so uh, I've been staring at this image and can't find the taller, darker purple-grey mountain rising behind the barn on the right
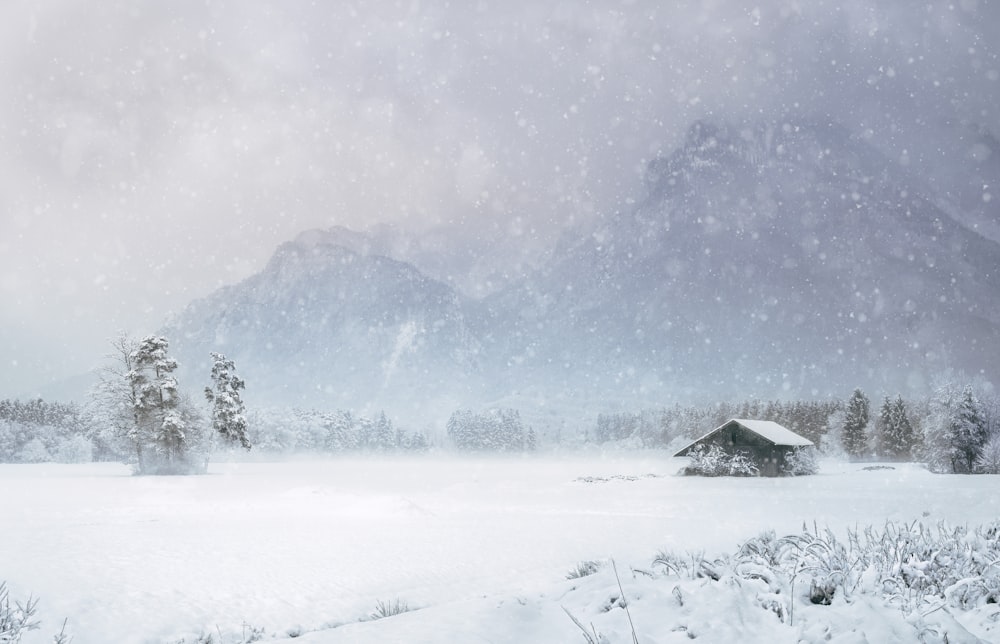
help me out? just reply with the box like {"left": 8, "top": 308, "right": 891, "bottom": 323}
{"left": 480, "top": 122, "right": 1000, "bottom": 398}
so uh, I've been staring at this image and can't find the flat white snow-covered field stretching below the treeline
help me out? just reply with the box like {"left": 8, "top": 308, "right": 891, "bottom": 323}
{"left": 0, "top": 452, "right": 1000, "bottom": 644}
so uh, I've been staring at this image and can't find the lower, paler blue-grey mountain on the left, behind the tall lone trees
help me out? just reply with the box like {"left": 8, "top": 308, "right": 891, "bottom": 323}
{"left": 164, "top": 230, "right": 479, "bottom": 422}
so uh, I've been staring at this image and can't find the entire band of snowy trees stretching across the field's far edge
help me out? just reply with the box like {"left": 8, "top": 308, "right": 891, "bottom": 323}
{"left": 0, "top": 372, "right": 1000, "bottom": 474}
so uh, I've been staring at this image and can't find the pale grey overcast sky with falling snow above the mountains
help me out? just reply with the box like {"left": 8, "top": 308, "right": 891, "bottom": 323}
{"left": 0, "top": 0, "right": 1000, "bottom": 398}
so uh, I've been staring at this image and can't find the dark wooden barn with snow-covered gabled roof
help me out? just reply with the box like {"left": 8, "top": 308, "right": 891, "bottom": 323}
{"left": 674, "top": 418, "right": 813, "bottom": 476}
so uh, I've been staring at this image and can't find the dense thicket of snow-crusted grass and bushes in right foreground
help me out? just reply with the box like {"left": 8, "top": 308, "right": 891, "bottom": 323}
{"left": 653, "top": 522, "right": 1000, "bottom": 621}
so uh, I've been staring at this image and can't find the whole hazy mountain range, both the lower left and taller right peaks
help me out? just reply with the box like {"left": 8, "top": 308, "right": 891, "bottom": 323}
{"left": 168, "top": 119, "right": 1000, "bottom": 426}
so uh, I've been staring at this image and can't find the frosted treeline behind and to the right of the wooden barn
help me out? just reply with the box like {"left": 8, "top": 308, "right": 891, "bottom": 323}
{"left": 587, "top": 382, "right": 1000, "bottom": 474}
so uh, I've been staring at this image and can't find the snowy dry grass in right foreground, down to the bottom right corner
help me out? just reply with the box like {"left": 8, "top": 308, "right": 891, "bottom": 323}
{"left": 640, "top": 522, "right": 1000, "bottom": 643}
